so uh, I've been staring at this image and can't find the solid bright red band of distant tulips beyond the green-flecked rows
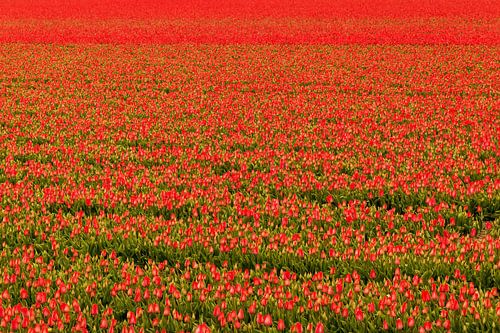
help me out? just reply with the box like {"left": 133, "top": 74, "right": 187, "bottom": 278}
{"left": 0, "top": 0, "right": 500, "bottom": 46}
